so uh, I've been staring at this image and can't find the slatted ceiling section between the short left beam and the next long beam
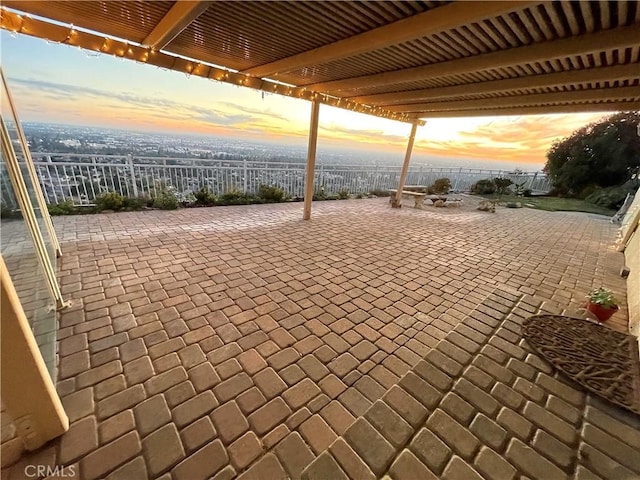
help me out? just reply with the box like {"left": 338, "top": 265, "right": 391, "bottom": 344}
{"left": 170, "top": 1, "right": 444, "bottom": 73}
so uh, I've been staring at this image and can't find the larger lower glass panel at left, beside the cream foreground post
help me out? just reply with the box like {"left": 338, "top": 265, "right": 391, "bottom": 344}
{"left": 0, "top": 155, "right": 56, "bottom": 382}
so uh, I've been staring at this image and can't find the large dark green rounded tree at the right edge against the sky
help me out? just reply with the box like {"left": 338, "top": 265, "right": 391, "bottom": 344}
{"left": 544, "top": 112, "right": 640, "bottom": 195}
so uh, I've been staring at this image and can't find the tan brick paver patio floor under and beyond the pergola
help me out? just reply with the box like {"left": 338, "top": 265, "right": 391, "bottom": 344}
{"left": 3, "top": 199, "right": 640, "bottom": 480}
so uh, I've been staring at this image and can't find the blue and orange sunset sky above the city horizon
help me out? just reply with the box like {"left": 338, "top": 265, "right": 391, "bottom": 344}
{"left": 0, "top": 30, "right": 607, "bottom": 170}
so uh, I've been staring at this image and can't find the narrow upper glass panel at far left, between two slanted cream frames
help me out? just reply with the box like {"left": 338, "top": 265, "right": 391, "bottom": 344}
{"left": 1, "top": 89, "right": 56, "bottom": 265}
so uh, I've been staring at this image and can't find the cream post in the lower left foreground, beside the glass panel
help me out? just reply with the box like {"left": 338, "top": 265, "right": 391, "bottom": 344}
{"left": 0, "top": 257, "right": 69, "bottom": 450}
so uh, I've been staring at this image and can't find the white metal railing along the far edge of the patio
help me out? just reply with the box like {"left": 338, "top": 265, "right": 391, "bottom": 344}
{"left": 0, "top": 153, "right": 551, "bottom": 205}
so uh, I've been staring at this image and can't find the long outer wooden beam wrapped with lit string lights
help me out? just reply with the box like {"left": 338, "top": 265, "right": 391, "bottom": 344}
{"left": 0, "top": 10, "right": 415, "bottom": 123}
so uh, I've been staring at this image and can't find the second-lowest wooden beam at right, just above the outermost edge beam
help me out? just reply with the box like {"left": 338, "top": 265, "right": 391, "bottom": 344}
{"left": 388, "top": 87, "right": 640, "bottom": 113}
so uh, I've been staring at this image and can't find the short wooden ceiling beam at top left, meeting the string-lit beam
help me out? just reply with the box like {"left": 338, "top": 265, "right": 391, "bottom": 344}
{"left": 142, "top": 0, "right": 213, "bottom": 50}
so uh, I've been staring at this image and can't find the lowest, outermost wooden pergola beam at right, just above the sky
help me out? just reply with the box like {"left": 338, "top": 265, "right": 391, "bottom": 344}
{"left": 408, "top": 101, "right": 640, "bottom": 119}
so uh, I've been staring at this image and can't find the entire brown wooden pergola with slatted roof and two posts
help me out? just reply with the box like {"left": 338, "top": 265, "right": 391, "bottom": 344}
{"left": 2, "top": 0, "right": 640, "bottom": 219}
